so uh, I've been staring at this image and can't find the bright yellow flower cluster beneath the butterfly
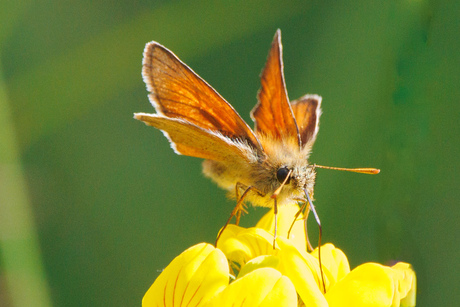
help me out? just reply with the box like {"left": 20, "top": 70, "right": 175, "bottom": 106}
{"left": 142, "top": 205, "right": 416, "bottom": 307}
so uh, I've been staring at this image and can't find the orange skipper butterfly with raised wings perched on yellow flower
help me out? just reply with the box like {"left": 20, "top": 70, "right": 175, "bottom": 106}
{"left": 134, "top": 30, "right": 379, "bottom": 254}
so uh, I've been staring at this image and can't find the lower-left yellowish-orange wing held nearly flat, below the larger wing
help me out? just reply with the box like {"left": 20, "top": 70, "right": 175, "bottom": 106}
{"left": 134, "top": 113, "right": 254, "bottom": 165}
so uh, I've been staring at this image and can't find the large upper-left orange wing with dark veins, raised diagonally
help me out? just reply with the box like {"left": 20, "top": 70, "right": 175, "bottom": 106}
{"left": 142, "top": 42, "right": 262, "bottom": 155}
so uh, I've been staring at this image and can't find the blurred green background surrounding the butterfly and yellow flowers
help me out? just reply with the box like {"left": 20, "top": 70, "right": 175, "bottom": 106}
{"left": 0, "top": 0, "right": 460, "bottom": 306}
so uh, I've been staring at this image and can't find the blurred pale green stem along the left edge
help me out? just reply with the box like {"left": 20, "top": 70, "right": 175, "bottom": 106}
{"left": 0, "top": 63, "right": 52, "bottom": 307}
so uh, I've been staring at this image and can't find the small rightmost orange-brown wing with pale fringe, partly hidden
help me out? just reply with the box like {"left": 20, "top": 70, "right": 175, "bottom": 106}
{"left": 291, "top": 95, "right": 321, "bottom": 147}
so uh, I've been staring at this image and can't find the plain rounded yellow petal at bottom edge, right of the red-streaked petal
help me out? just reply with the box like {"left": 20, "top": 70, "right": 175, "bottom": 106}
{"left": 205, "top": 268, "right": 297, "bottom": 307}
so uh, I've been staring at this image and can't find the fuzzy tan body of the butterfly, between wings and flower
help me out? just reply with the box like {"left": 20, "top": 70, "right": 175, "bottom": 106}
{"left": 203, "top": 135, "right": 316, "bottom": 207}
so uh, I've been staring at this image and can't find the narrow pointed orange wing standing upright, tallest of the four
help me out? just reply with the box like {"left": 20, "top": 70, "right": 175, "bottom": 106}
{"left": 251, "top": 30, "right": 300, "bottom": 146}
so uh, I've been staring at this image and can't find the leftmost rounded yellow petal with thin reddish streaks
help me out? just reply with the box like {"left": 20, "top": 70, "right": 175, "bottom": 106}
{"left": 142, "top": 243, "right": 229, "bottom": 307}
